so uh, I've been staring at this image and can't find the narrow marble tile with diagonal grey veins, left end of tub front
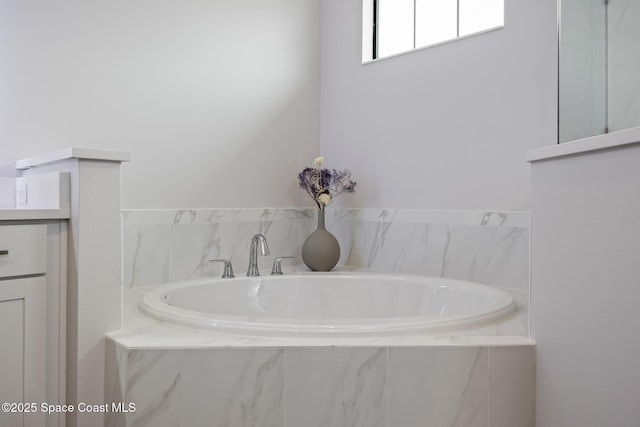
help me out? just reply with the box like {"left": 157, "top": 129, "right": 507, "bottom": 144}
{"left": 125, "top": 349, "right": 180, "bottom": 427}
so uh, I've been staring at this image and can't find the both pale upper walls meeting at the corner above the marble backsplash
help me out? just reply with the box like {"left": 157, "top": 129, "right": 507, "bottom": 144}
{"left": 0, "top": 0, "right": 556, "bottom": 210}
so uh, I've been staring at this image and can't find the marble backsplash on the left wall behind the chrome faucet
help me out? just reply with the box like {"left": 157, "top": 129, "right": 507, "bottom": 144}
{"left": 122, "top": 209, "right": 313, "bottom": 288}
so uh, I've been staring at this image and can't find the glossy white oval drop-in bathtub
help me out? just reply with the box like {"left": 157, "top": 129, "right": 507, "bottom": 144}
{"left": 140, "top": 273, "right": 515, "bottom": 338}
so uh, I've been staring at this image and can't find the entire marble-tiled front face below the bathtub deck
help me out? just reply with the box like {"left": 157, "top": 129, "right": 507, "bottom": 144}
{"left": 106, "top": 339, "right": 535, "bottom": 427}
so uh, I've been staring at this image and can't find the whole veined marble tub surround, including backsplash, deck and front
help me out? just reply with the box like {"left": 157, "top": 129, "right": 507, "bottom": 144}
{"left": 116, "top": 209, "right": 535, "bottom": 427}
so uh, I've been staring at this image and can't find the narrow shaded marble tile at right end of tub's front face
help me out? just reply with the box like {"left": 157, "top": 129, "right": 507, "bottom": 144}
{"left": 489, "top": 345, "right": 536, "bottom": 427}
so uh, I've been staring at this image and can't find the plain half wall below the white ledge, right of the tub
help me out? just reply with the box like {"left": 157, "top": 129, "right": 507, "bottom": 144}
{"left": 531, "top": 144, "right": 640, "bottom": 427}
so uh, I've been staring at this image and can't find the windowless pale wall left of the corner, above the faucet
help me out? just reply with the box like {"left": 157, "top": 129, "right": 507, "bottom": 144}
{"left": 0, "top": 0, "right": 320, "bottom": 208}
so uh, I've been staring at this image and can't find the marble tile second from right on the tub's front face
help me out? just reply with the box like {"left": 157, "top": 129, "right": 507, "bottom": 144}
{"left": 389, "top": 347, "right": 489, "bottom": 427}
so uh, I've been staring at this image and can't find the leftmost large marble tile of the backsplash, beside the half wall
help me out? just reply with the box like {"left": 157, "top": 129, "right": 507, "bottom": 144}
{"left": 122, "top": 224, "right": 171, "bottom": 288}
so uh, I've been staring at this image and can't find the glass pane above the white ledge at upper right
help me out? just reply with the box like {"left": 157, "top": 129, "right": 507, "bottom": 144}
{"left": 558, "top": 0, "right": 640, "bottom": 143}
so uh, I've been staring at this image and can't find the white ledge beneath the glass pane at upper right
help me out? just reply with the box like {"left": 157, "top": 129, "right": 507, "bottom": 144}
{"left": 526, "top": 127, "right": 640, "bottom": 162}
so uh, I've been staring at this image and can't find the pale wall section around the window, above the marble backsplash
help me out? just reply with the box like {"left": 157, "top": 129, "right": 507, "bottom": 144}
{"left": 321, "top": 0, "right": 557, "bottom": 210}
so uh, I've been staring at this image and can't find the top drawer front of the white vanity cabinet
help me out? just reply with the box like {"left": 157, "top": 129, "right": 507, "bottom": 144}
{"left": 0, "top": 224, "right": 47, "bottom": 278}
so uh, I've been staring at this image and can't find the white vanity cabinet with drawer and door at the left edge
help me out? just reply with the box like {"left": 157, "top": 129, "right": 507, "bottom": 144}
{"left": 0, "top": 221, "right": 66, "bottom": 427}
